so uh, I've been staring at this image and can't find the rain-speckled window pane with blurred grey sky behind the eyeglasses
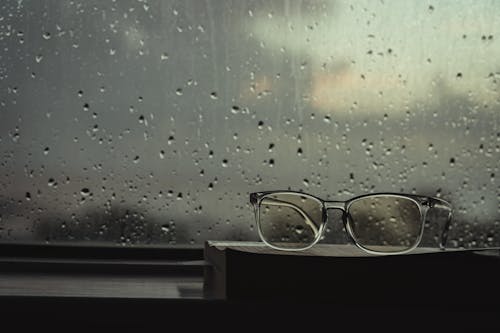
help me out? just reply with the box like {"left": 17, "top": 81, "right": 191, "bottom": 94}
{"left": 0, "top": 0, "right": 500, "bottom": 246}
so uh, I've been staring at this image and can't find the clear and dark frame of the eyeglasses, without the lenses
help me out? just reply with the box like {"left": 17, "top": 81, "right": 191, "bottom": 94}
{"left": 250, "top": 190, "right": 452, "bottom": 255}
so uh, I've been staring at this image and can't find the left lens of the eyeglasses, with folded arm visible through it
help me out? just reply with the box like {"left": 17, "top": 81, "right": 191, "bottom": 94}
{"left": 259, "top": 193, "right": 323, "bottom": 249}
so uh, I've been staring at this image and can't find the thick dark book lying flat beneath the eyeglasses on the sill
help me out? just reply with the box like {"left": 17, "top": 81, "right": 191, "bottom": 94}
{"left": 204, "top": 241, "right": 500, "bottom": 306}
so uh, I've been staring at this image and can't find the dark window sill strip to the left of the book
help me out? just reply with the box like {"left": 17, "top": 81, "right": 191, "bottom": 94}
{"left": 0, "top": 244, "right": 206, "bottom": 300}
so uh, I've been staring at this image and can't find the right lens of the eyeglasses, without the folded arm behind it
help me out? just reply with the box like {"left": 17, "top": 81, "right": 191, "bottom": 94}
{"left": 348, "top": 195, "right": 423, "bottom": 253}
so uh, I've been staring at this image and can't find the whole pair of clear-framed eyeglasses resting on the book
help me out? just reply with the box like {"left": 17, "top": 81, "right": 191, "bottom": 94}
{"left": 250, "top": 191, "right": 452, "bottom": 254}
